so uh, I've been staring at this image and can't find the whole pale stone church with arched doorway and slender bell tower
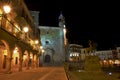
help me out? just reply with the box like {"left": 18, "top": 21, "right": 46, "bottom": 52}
{"left": 32, "top": 11, "right": 66, "bottom": 66}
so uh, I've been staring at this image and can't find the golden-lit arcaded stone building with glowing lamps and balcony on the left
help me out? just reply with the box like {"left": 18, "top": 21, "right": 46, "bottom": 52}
{"left": 0, "top": 0, "right": 40, "bottom": 73}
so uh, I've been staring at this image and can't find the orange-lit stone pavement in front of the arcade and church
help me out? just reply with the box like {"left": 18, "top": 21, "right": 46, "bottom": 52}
{"left": 0, "top": 67, "right": 68, "bottom": 80}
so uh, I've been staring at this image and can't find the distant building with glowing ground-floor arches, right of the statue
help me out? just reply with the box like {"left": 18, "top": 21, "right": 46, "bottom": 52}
{"left": 95, "top": 47, "right": 120, "bottom": 67}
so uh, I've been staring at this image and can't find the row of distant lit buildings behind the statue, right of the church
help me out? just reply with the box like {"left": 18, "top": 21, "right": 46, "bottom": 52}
{"left": 68, "top": 44, "right": 120, "bottom": 68}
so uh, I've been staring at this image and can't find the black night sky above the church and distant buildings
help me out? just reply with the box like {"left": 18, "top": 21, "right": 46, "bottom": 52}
{"left": 24, "top": 0, "right": 120, "bottom": 50}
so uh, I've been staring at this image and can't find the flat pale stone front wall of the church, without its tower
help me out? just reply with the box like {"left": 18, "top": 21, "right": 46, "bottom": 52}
{"left": 39, "top": 26, "right": 65, "bottom": 65}
